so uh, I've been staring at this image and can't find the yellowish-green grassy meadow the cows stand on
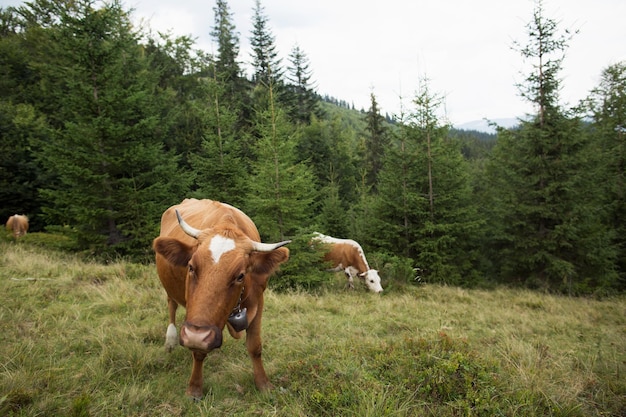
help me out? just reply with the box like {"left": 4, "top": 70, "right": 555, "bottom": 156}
{"left": 0, "top": 241, "right": 626, "bottom": 417}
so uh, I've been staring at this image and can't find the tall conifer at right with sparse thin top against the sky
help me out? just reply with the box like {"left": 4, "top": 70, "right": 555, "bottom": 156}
{"left": 490, "top": 2, "right": 612, "bottom": 292}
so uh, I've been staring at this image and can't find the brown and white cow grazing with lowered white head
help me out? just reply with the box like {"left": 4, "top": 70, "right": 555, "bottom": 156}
{"left": 313, "top": 232, "right": 383, "bottom": 293}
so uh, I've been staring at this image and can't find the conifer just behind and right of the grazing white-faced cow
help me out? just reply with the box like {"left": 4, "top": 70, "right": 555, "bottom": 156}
{"left": 375, "top": 80, "right": 481, "bottom": 285}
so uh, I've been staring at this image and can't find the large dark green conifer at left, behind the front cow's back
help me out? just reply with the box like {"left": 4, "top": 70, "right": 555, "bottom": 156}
{"left": 26, "top": 0, "right": 189, "bottom": 255}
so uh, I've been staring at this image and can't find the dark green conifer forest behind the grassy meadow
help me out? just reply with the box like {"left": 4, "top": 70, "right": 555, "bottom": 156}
{"left": 0, "top": 0, "right": 626, "bottom": 296}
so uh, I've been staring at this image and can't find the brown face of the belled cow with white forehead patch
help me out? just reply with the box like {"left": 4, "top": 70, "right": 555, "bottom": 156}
{"left": 154, "top": 213, "right": 289, "bottom": 352}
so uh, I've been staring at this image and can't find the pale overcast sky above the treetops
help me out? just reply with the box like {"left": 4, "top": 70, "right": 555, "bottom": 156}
{"left": 0, "top": 0, "right": 626, "bottom": 125}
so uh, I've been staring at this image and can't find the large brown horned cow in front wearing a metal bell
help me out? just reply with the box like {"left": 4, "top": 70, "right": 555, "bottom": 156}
{"left": 153, "top": 199, "right": 289, "bottom": 398}
